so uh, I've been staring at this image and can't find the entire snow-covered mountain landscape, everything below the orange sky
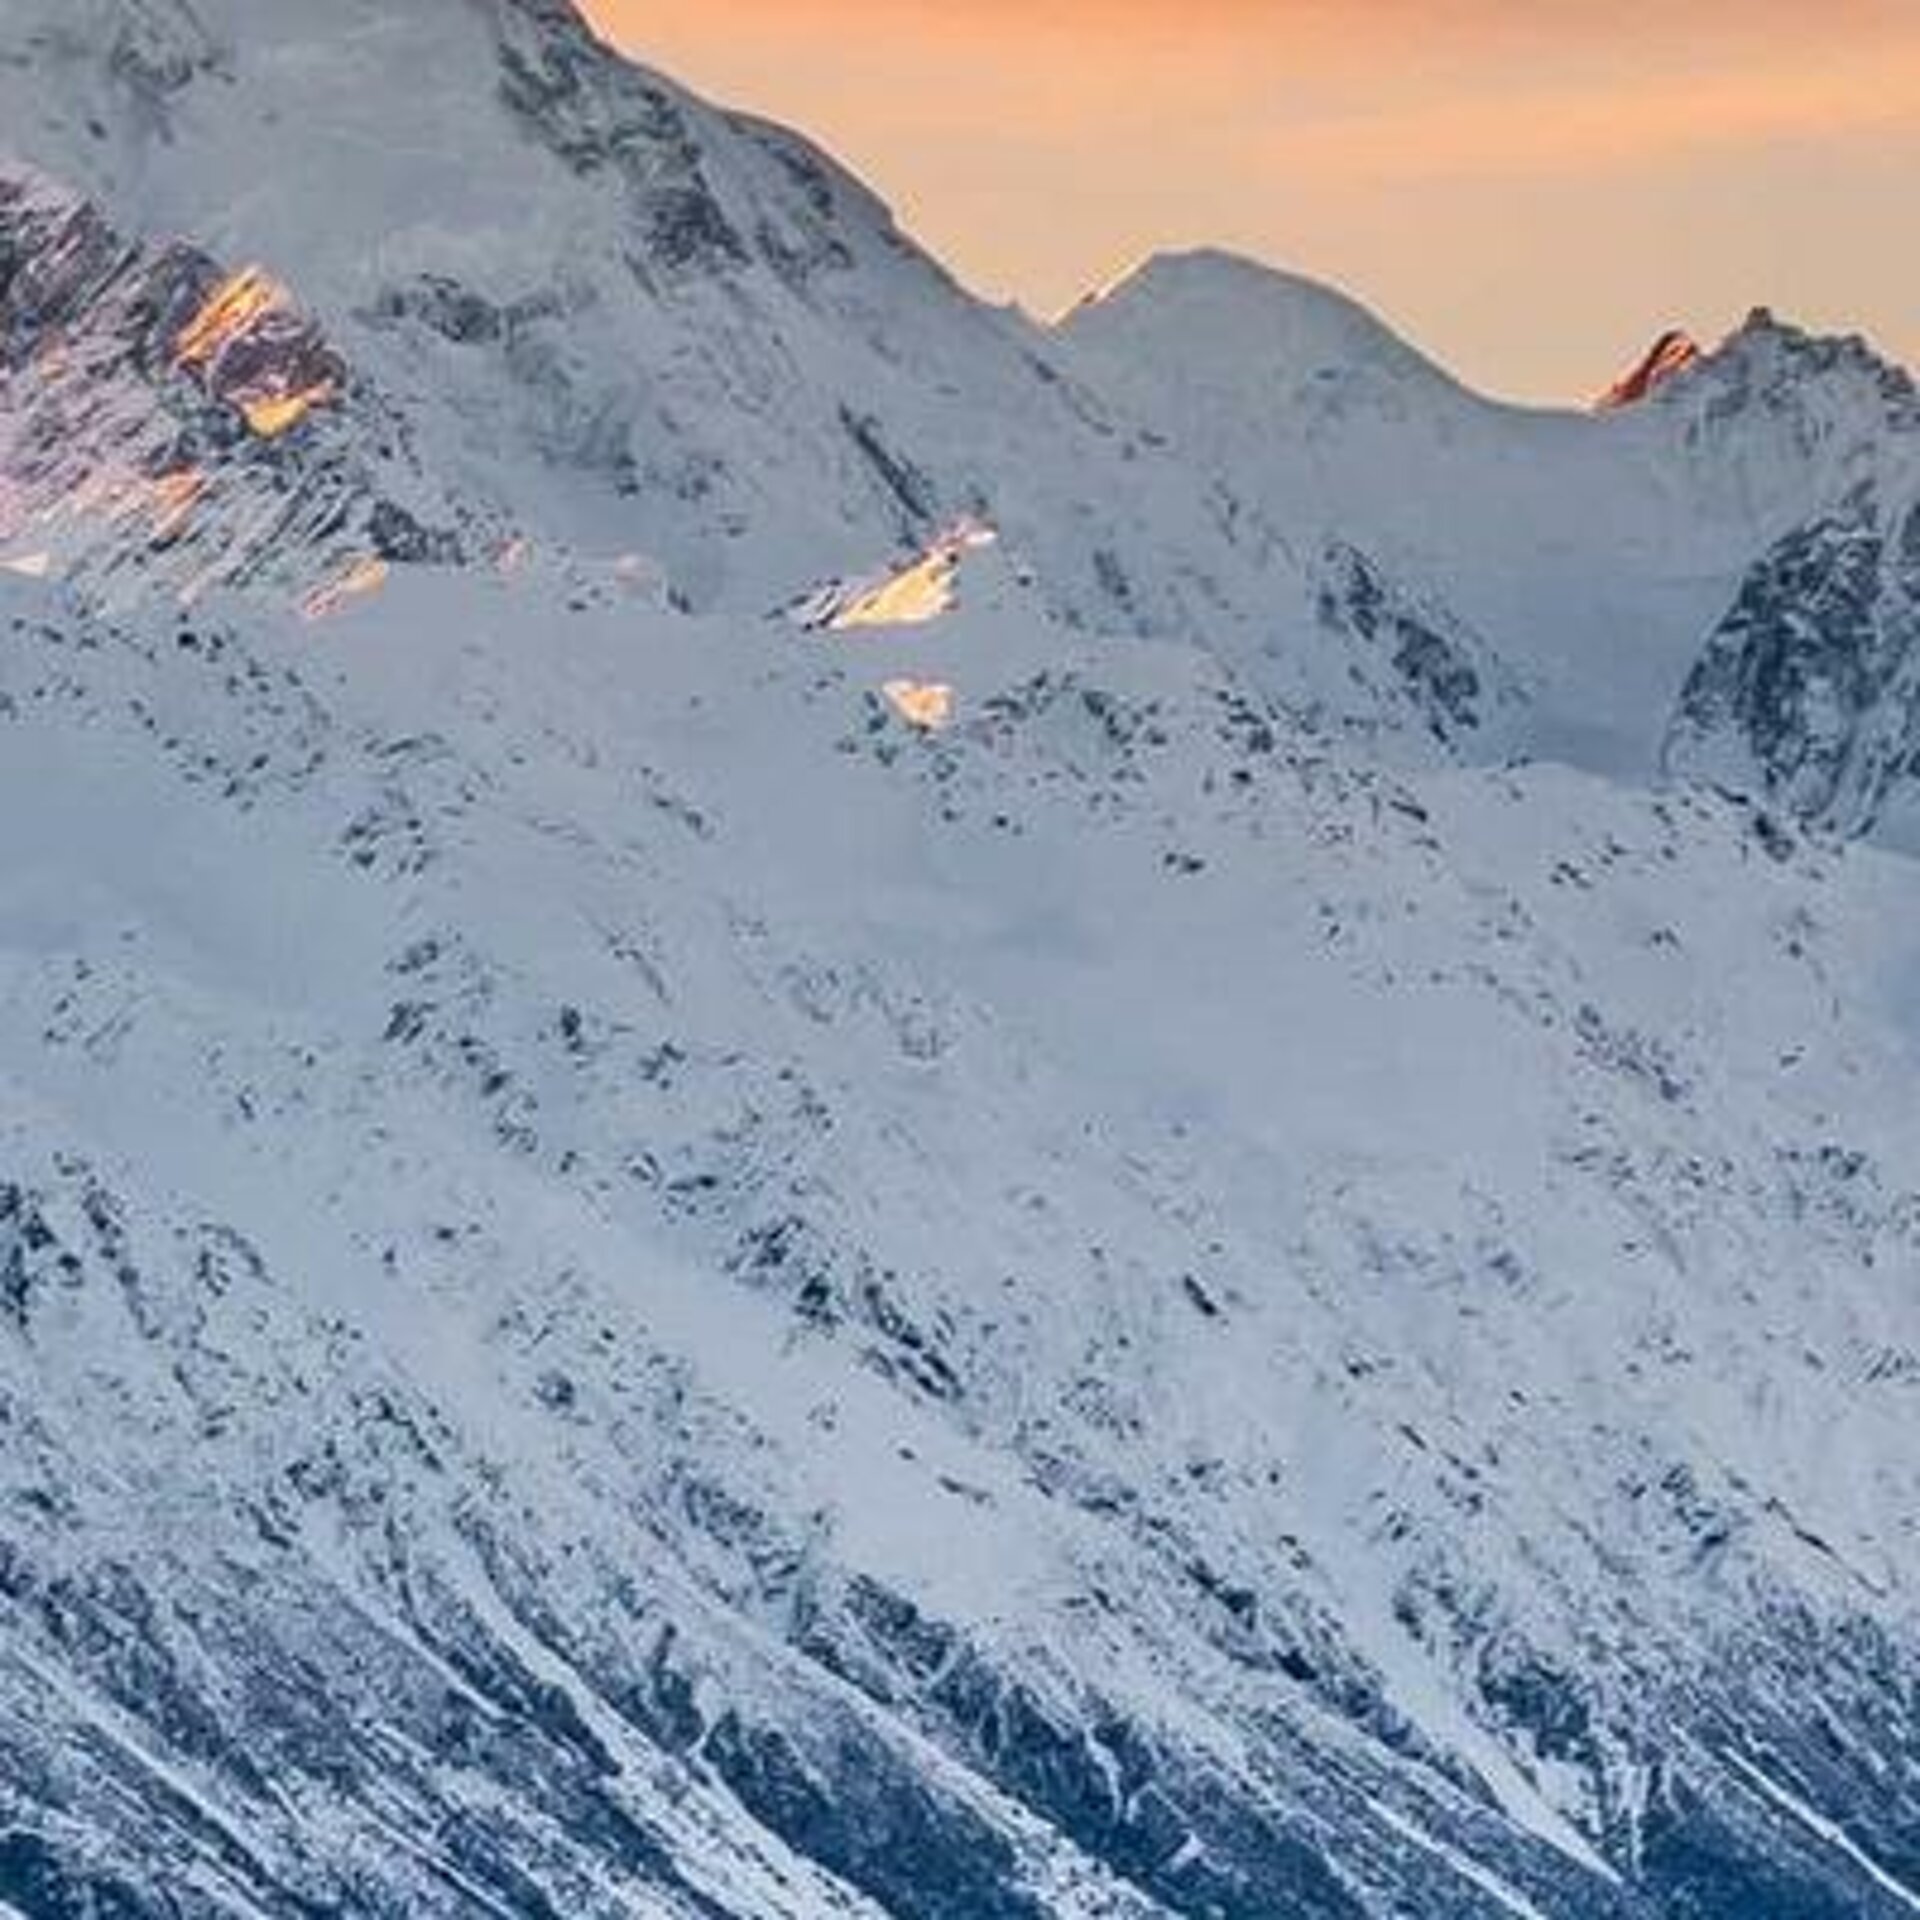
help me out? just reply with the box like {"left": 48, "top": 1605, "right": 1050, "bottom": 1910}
{"left": 0, "top": 0, "right": 1920, "bottom": 1920}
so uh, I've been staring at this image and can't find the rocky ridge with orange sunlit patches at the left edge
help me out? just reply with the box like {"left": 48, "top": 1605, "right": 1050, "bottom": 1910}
{"left": 0, "top": 169, "right": 465, "bottom": 599}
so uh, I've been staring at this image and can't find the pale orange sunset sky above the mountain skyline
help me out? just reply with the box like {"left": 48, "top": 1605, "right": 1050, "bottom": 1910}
{"left": 589, "top": 0, "right": 1920, "bottom": 399}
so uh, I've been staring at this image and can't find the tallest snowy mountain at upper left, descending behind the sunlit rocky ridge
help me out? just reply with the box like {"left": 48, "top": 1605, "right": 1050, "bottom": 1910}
{"left": 0, "top": 0, "right": 1304, "bottom": 652}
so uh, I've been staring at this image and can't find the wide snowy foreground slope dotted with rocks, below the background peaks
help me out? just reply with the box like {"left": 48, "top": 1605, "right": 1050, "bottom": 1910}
{"left": 0, "top": 549, "right": 1920, "bottom": 1914}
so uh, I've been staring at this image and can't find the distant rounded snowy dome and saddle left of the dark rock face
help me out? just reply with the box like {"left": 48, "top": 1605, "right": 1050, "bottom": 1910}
{"left": 1064, "top": 253, "right": 1920, "bottom": 806}
